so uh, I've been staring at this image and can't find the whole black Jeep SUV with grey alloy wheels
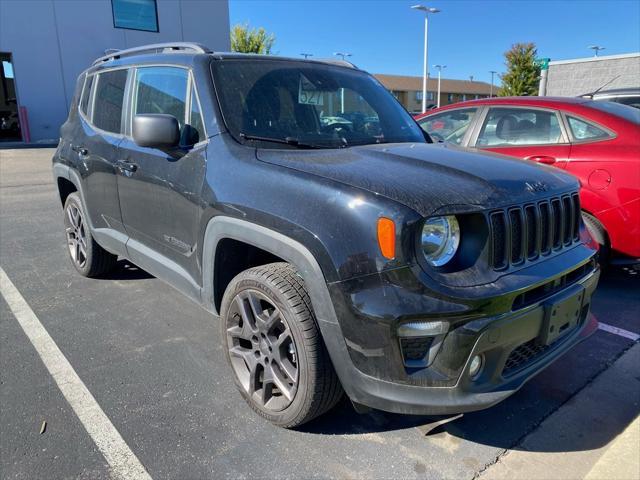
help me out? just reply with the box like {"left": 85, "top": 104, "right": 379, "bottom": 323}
{"left": 53, "top": 44, "right": 599, "bottom": 427}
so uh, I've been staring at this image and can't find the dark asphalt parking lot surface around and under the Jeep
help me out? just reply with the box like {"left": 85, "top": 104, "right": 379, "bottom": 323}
{"left": 0, "top": 149, "right": 640, "bottom": 479}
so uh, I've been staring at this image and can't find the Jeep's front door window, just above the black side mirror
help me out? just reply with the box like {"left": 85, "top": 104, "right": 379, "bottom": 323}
{"left": 133, "top": 67, "right": 189, "bottom": 128}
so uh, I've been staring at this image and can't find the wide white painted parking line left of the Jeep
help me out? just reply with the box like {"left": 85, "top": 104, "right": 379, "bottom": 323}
{"left": 0, "top": 267, "right": 151, "bottom": 479}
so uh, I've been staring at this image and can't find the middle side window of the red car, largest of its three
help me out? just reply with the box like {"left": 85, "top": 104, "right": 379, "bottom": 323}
{"left": 476, "top": 108, "right": 562, "bottom": 147}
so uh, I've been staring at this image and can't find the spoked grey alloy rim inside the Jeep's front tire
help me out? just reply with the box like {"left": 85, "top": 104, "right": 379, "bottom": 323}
{"left": 226, "top": 290, "right": 299, "bottom": 411}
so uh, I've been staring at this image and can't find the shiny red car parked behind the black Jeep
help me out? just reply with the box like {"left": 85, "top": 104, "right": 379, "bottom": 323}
{"left": 416, "top": 97, "right": 640, "bottom": 264}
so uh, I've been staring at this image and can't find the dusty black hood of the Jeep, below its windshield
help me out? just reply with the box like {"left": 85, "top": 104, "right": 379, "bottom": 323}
{"left": 257, "top": 143, "right": 579, "bottom": 216}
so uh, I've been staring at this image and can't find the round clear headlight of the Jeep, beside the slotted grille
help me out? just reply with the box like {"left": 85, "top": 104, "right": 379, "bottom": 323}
{"left": 421, "top": 215, "right": 460, "bottom": 267}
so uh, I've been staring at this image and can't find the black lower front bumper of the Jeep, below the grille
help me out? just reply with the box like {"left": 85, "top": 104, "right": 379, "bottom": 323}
{"left": 322, "top": 253, "right": 600, "bottom": 415}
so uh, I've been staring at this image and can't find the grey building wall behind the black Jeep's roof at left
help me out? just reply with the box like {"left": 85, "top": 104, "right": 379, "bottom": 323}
{"left": 0, "top": 0, "right": 230, "bottom": 141}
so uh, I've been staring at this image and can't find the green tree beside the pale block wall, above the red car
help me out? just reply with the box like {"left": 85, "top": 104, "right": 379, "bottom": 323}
{"left": 498, "top": 43, "right": 540, "bottom": 97}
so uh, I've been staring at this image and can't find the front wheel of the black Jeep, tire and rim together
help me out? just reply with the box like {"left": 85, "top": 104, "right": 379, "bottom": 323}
{"left": 220, "top": 263, "right": 343, "bottom": 428}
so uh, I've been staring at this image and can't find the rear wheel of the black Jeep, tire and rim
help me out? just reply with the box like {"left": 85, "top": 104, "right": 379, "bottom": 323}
{"left": 64, "top": 192, "right": 118, "bottom": 277}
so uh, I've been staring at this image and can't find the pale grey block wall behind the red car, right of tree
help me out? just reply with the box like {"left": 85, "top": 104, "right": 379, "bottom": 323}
{"left": 547, "top": 53, "right": 640, "bottom": 97}
